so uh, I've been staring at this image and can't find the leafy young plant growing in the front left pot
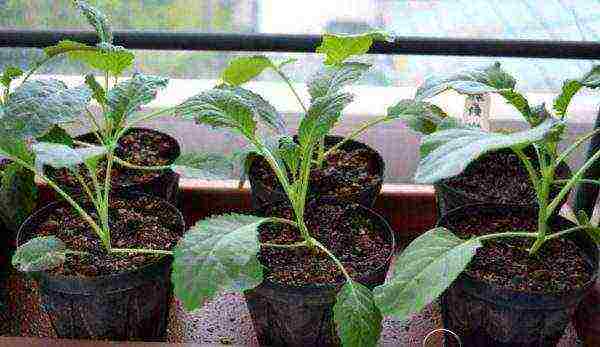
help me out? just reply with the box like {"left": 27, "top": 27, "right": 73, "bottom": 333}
{"left": 11, "top": 1, "right": 232, "bottom": 271}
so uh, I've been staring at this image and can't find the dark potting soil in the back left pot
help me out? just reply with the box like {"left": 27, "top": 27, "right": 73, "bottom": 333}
{"left": 45, "top": 129, "right": 178, "bottom": 189}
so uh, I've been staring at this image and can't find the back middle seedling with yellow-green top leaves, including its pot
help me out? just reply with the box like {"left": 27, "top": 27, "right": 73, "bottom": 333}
{"left": 221, "top": 33, "right": 404, "bottom": 210}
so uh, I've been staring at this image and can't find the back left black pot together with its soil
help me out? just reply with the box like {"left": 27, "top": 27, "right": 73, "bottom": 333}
{"left": 45, "top": 128, "right": 180, "bottom": 203}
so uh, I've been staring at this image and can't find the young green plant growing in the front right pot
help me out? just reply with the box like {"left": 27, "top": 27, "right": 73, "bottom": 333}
{"left": 375, "top": 66, "right": 600, "bottom": 319}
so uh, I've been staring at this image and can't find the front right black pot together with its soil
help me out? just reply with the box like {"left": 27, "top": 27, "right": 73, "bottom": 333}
{"left": 440, "top": 204, "right": 598, "bottom": 347}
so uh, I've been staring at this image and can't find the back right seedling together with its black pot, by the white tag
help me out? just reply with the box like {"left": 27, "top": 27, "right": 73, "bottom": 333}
{"left": 399, "top": 62, "right": 570, "bottom": 216}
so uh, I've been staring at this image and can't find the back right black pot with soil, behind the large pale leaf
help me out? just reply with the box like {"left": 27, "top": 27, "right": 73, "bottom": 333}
{"left": 435, "top": 149, "right": 570, "bottom": 216}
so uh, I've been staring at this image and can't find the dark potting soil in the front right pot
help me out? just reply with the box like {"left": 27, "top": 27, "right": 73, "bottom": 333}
{"left": 444, "top": 208, "right": 593, "bottom": 294}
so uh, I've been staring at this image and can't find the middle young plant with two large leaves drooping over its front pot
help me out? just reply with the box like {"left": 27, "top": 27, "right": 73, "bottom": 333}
{"left": 164, "top": 34, "right": 440, "bottom": 346}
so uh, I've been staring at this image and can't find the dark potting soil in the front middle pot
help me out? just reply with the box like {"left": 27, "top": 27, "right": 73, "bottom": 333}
{"left": 259, "top": 204, "right": 392, "bottom": 286}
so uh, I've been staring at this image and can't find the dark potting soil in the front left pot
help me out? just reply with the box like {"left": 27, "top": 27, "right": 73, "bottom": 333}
{"left": 30, "top": 196, "right": 182, "bottom": 277}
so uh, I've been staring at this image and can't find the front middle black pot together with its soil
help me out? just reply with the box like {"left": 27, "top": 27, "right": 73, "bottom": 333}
{"left": 245, "top": 203, "right": 394, "bottom": 346}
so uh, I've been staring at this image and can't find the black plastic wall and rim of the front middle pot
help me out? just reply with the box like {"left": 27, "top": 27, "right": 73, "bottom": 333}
{"left": 244, "top": 199, "right": 395, "bottom": 346}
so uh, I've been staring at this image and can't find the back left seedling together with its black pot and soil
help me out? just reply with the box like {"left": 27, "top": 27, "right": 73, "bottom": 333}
{"left": 31, "top": 1, "right": 180, "bottom": 202}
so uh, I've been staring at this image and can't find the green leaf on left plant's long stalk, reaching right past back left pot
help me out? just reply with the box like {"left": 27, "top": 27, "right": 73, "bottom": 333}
{"left": 171, "top": 152, "right": 234, "bottom": 180}
